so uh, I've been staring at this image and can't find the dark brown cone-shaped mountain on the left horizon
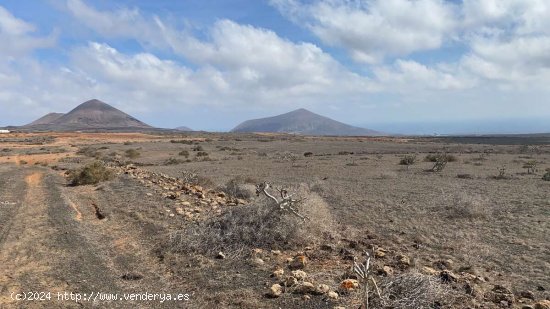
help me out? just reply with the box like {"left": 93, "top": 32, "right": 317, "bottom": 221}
{"left": 25, "top": 99, "right": 151, "bottom": 131}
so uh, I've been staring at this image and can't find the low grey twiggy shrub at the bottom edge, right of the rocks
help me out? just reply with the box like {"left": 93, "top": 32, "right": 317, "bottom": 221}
{"left": 372, "top": 272, "right": 457, "bottom": 309}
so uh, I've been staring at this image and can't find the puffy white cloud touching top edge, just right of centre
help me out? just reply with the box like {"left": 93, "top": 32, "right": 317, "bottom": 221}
{"left": 272, "top": 0, "right": 457, "bottom": 64}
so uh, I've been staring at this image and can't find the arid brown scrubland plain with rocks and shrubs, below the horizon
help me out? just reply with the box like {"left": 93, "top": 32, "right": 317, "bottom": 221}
{"left": 0, "top": 133, "right": 550, "bottom": 308}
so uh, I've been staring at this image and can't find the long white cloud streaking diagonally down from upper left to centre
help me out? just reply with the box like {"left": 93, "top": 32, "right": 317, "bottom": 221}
{"left": 68, "top": 0, "right": 369, "bottom": 94}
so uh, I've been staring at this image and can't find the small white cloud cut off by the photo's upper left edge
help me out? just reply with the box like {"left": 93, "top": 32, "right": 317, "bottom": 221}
{"left": 0, "top": 6, "right": 57, "bottom": 57}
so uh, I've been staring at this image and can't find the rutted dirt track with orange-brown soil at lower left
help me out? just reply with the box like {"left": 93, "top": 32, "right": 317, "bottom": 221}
{"left": 0, "top": 165, "right": 183, "bottom": 308}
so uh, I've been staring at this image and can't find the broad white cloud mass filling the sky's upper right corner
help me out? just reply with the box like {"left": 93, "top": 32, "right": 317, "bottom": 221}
{"left": 271, "top": 0, "right": 550, "bottom": 89}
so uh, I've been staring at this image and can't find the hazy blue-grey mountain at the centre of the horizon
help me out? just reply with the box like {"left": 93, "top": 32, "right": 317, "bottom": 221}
{"left": 231, "top": 108, "right": 380, "bottom": 136}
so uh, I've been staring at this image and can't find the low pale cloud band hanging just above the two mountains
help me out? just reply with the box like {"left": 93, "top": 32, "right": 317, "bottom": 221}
{"left": 68, "top": 37, "right": 369, "bottom": 106}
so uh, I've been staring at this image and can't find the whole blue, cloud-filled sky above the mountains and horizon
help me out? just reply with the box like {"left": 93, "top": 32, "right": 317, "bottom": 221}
{"left": 0, "top": 0, "right": 550, "bottom": 134}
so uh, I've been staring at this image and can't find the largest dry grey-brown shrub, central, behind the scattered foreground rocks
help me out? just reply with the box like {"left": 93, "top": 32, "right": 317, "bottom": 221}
{"left": 170, "top": 185, "right": 335, "bottom": 257}
